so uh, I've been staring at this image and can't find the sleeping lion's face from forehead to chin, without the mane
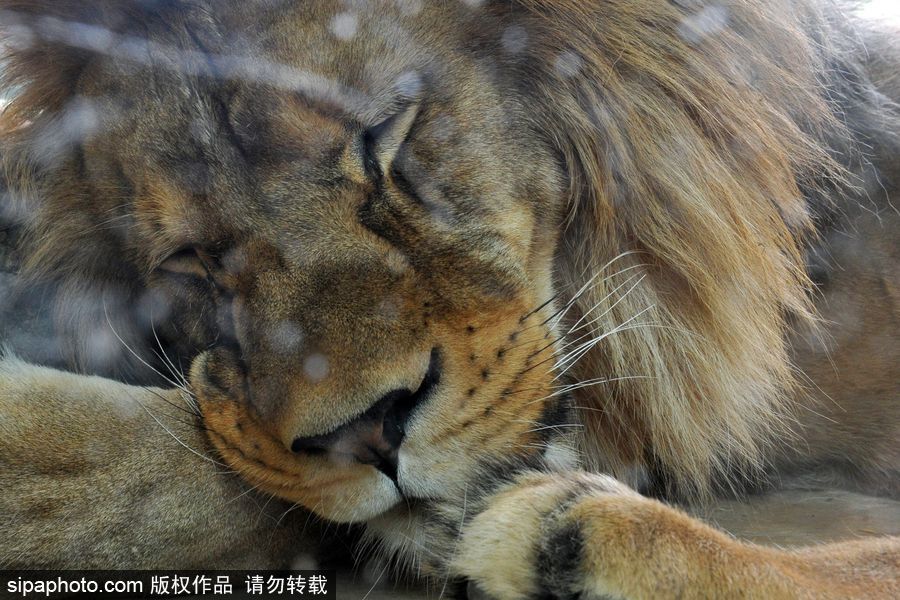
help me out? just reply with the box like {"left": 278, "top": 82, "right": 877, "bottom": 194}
{"left": 3, "top": 2, "right": 565, "bottom": 520}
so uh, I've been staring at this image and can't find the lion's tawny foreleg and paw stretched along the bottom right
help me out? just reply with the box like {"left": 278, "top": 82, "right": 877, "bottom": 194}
{"left": 452, "top": 473, "right": 900, "bottom": 600}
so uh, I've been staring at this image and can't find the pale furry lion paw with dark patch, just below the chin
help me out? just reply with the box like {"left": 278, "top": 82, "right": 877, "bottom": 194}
{"left": 452, "top": 473, "right": 650, "bottom": 600}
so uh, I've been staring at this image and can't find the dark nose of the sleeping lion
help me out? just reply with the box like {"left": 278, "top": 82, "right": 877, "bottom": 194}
{"left": 291, "top": 349, "right": 441, "bottom": 483}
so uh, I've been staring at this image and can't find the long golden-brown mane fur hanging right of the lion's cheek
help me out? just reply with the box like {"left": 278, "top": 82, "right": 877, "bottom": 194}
{"left": 520, "top": 2, "right": 839, "bottom": 486}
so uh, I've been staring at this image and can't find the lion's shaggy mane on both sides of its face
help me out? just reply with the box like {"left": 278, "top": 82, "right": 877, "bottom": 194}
{"left": 0, "top": 0, "right": 883, "bottom": 494}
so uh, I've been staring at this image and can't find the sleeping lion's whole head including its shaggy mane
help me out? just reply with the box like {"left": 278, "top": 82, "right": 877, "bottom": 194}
{"left": 0, "top": 0, "right": 856, "bottom": 520}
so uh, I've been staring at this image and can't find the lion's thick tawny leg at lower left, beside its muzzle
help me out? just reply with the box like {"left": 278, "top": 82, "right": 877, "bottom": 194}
{"left": 0, "top": 357, "right": 309, "bottom": 569}
